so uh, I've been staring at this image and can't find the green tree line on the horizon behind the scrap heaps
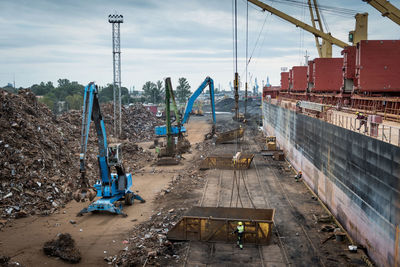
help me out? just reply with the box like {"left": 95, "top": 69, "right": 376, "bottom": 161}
{"left": 0, "top": 78, "right": 191, "bottom": 111}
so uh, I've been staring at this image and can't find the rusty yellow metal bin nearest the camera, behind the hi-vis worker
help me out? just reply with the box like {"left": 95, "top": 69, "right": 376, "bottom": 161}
{"left": 167, "top": 207, "right": 275, "bottom": 245}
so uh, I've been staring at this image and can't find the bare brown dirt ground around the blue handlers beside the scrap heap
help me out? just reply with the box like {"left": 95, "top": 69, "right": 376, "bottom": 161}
{"left": 0, "top": 119, "right": 211, "bottom": 266}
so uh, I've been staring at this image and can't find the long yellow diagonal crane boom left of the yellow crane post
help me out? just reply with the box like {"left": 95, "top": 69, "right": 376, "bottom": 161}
{"left": 247, "top": 0, "right": 349, "bottom": 48}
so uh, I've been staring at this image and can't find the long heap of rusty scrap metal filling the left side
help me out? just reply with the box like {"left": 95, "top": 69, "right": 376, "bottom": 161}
{"left": 0, "top": 90, "right": 159, "bottom": 222}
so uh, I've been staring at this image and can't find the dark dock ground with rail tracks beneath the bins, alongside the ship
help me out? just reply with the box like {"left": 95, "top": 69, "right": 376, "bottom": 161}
{"left": 184, "top": 122, "right": 350, "bottom": 266}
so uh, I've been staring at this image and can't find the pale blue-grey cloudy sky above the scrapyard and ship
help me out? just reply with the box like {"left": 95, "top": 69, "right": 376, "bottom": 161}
{"left": 0, "top": 0, "right": 400, "bottom": 90}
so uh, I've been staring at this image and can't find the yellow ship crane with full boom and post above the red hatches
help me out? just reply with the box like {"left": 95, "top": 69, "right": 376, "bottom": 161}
{"left": 247, "top": 0, "right": 368, "bottom": 57}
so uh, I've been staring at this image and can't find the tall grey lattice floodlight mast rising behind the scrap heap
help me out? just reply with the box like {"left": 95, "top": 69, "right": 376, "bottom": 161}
{"left": 108, "top": 14, "right": 124, "bottom": 138}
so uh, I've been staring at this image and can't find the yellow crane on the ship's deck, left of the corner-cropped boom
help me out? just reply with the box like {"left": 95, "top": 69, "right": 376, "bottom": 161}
{"left": 247, "top": 0, "right": 367, "bottom": 57}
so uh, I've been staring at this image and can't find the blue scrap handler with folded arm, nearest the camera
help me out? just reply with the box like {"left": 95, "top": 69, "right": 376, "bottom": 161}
{"left": 74, "top": 82, "right": 145, "bottom": 215}
